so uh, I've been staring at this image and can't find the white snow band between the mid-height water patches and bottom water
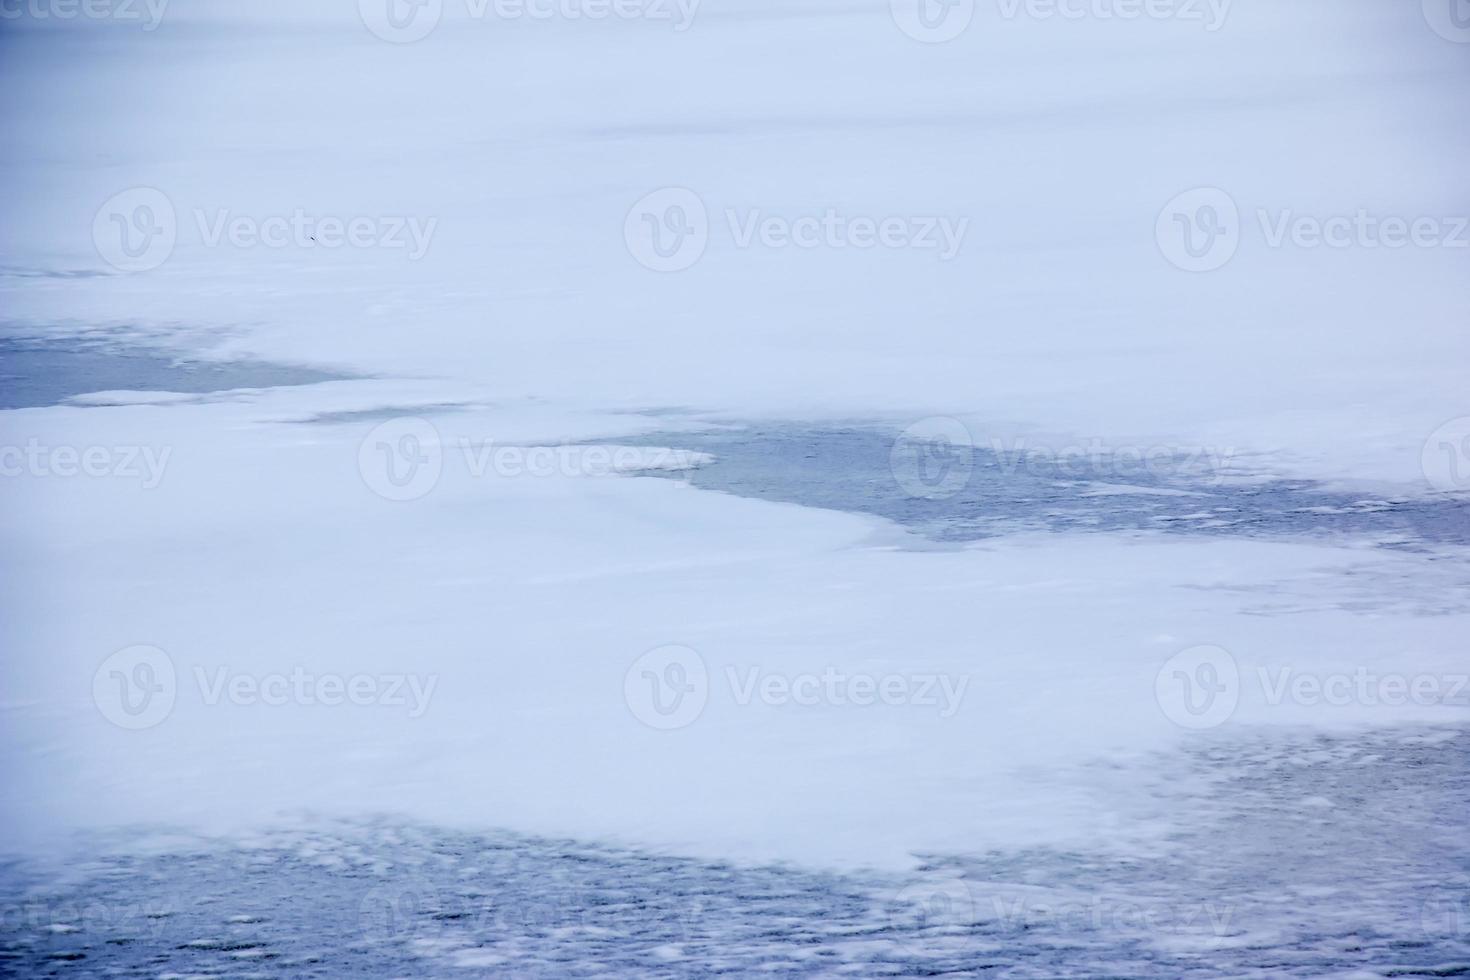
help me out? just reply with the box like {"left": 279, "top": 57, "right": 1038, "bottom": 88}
{"left": 0, "top": 382, "right": 1470, "bottom": 867}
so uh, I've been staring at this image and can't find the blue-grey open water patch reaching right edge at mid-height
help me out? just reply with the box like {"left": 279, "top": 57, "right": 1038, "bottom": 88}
{"left": 620, "top": 423, "right": 1470, "bottom": 550}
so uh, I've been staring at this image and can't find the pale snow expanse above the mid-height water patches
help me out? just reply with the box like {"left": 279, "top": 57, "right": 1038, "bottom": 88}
{"left": 0, "top": 0, "right": 1470, "bottom": 483}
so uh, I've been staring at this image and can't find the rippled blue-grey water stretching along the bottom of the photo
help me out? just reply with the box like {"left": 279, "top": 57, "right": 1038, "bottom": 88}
{"left": 0, "top": 730, "right": 1470, "bottom": 979}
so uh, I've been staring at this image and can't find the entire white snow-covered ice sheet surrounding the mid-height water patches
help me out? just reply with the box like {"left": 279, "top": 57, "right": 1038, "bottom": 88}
{"left": 0, "top": 0, "right": 1470, "bottom": 967}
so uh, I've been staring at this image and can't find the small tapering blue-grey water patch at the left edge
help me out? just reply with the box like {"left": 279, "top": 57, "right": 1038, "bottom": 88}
{"left": 0, "top": 338, "right": 341, "bottom": 410}
